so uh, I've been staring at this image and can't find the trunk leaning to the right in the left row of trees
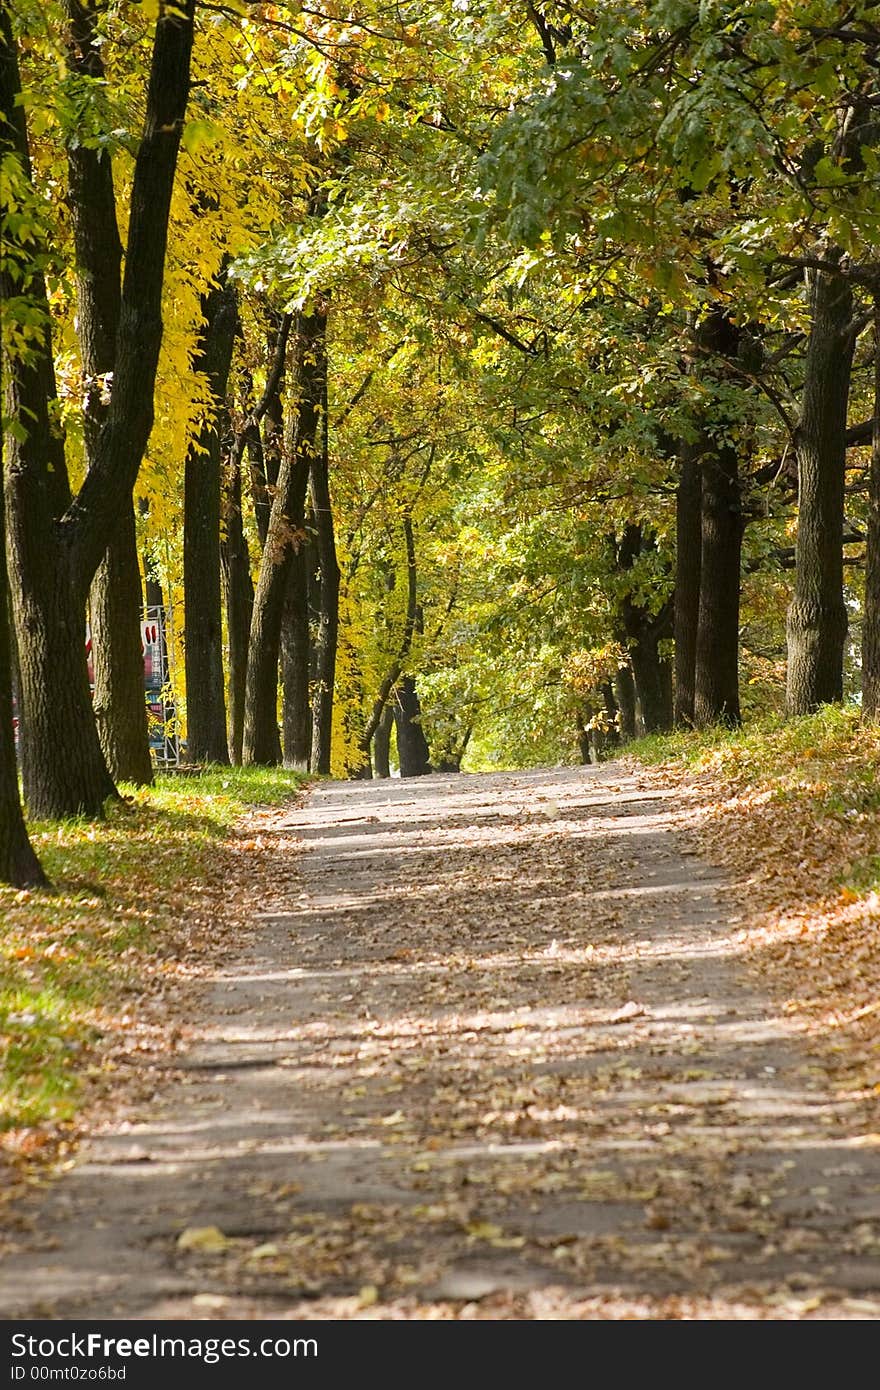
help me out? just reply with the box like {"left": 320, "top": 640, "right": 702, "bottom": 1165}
{"left": 243, "top": 310, "right": 316, "bottom": 766}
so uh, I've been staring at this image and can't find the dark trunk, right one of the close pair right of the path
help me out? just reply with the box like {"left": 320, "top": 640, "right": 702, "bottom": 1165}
{"left": 694, "top": 443, "right": 742, "bottom": 728}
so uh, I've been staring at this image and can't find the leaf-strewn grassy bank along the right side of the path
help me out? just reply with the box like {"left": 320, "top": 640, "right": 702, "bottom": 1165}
{"left": 627, "top": 706, "right": 880, "bottom": 1095}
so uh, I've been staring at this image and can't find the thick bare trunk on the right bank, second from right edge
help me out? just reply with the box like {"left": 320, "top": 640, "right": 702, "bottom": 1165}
{"left": 785, "top": 259, "right": 855, "bottom": 714}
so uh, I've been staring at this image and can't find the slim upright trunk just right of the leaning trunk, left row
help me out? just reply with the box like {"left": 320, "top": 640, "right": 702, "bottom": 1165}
{"left": 309, "top": 332, "right": 339, "bottom": 774}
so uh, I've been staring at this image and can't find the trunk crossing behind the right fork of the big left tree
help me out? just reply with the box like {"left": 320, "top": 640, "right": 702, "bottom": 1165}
{"left": 64, "top": 0, "right": 153, "bottom": 785}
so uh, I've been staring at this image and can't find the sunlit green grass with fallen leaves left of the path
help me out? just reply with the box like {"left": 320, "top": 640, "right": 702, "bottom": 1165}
{"left": 0, "top": 767, "right": 303, "bottom": 1138}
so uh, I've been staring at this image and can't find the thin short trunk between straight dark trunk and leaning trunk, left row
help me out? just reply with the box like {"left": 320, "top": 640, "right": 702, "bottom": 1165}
{"left": 221, "top": 456, "right": 253, "bottom": 767}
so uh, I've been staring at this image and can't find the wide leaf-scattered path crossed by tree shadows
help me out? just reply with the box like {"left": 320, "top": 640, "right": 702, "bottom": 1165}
{"left": 0, "top": 765, "right": 880, "bottom": 1319}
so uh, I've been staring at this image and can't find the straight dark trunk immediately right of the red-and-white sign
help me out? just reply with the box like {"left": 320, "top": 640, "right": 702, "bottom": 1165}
{"left": 184, "top": 276, "right": 238, "bottom": 763}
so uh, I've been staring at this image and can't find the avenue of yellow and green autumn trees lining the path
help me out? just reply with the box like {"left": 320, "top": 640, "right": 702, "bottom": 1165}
{"left": 0, "top": 0, "right": 880, "bottom": 884}
